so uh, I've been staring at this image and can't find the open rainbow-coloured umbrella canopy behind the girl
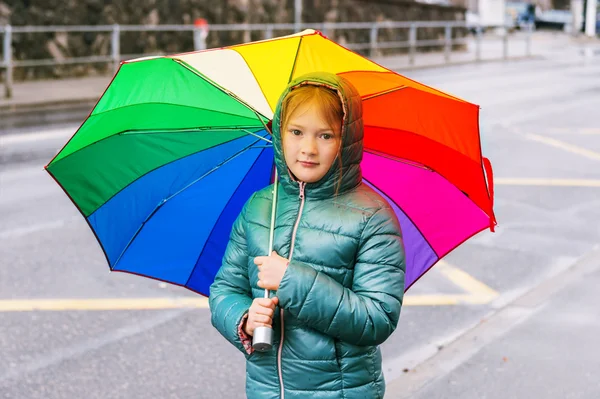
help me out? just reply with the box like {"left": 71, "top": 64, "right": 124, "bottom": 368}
{"left": 46, "top": 30, "right": 495, "bottom": 295}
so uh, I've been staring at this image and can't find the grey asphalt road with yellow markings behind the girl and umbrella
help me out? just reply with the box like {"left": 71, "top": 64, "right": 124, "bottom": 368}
{"left": 0, "top": 32, "right": 600, "bottom": 399}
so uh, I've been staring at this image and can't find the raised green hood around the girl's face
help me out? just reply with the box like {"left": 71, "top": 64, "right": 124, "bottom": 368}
{"left": 272, "top": 72, "right": 363, "bottom": 198}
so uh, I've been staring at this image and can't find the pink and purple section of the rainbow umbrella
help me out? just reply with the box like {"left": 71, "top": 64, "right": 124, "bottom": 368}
{"left": 361, "top": 152, "right": 490, "bottom": 290}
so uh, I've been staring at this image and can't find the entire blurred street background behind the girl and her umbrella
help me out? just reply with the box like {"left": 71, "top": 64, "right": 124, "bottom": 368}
{"left": 0, "top": 0, "right": 600, "bottom": 399}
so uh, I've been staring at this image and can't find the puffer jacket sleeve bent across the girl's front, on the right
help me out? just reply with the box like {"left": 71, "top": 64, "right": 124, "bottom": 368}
{"left": 277, "top": 208, "right": 405, "bottom": 345}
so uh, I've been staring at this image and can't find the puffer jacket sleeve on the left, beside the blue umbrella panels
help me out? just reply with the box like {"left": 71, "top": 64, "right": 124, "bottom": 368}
{"left": 208, "top": 197, "right": 252, "bottom": 355}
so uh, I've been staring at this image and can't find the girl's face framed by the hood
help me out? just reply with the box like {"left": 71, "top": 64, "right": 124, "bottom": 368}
{"left": 282, "top": 104, "right": 342, "bottom": 183}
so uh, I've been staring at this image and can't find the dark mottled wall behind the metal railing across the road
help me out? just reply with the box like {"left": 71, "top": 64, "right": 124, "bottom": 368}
{"left": 0, "top": 0, "right": 465, "bottom": 80}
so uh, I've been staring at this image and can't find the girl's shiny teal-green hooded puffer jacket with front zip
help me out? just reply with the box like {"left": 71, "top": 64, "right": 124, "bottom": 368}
{"left": 210, "top": 73, "right": 405, "bottom": 399}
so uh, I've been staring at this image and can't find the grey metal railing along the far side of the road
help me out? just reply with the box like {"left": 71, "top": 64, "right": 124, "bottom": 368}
{"left": 0, "top": 21, "right": 531, "bottom": 98}
